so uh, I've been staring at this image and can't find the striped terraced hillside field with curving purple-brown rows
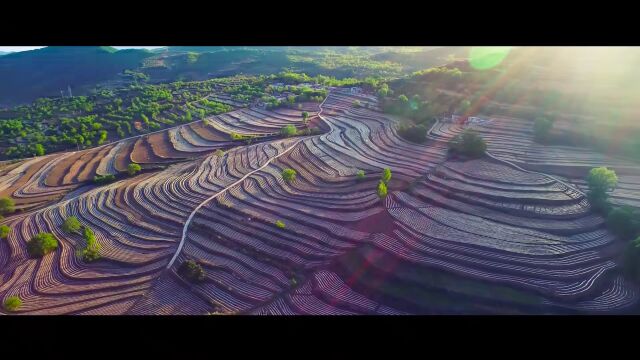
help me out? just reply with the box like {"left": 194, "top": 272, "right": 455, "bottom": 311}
{"left": 0, "top": 90, "right": 638, "bottom": 315}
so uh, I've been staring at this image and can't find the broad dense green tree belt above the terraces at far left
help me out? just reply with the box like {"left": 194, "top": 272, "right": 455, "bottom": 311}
{"left": 0, "top": 80, "right": 231, "bottom": 158}
